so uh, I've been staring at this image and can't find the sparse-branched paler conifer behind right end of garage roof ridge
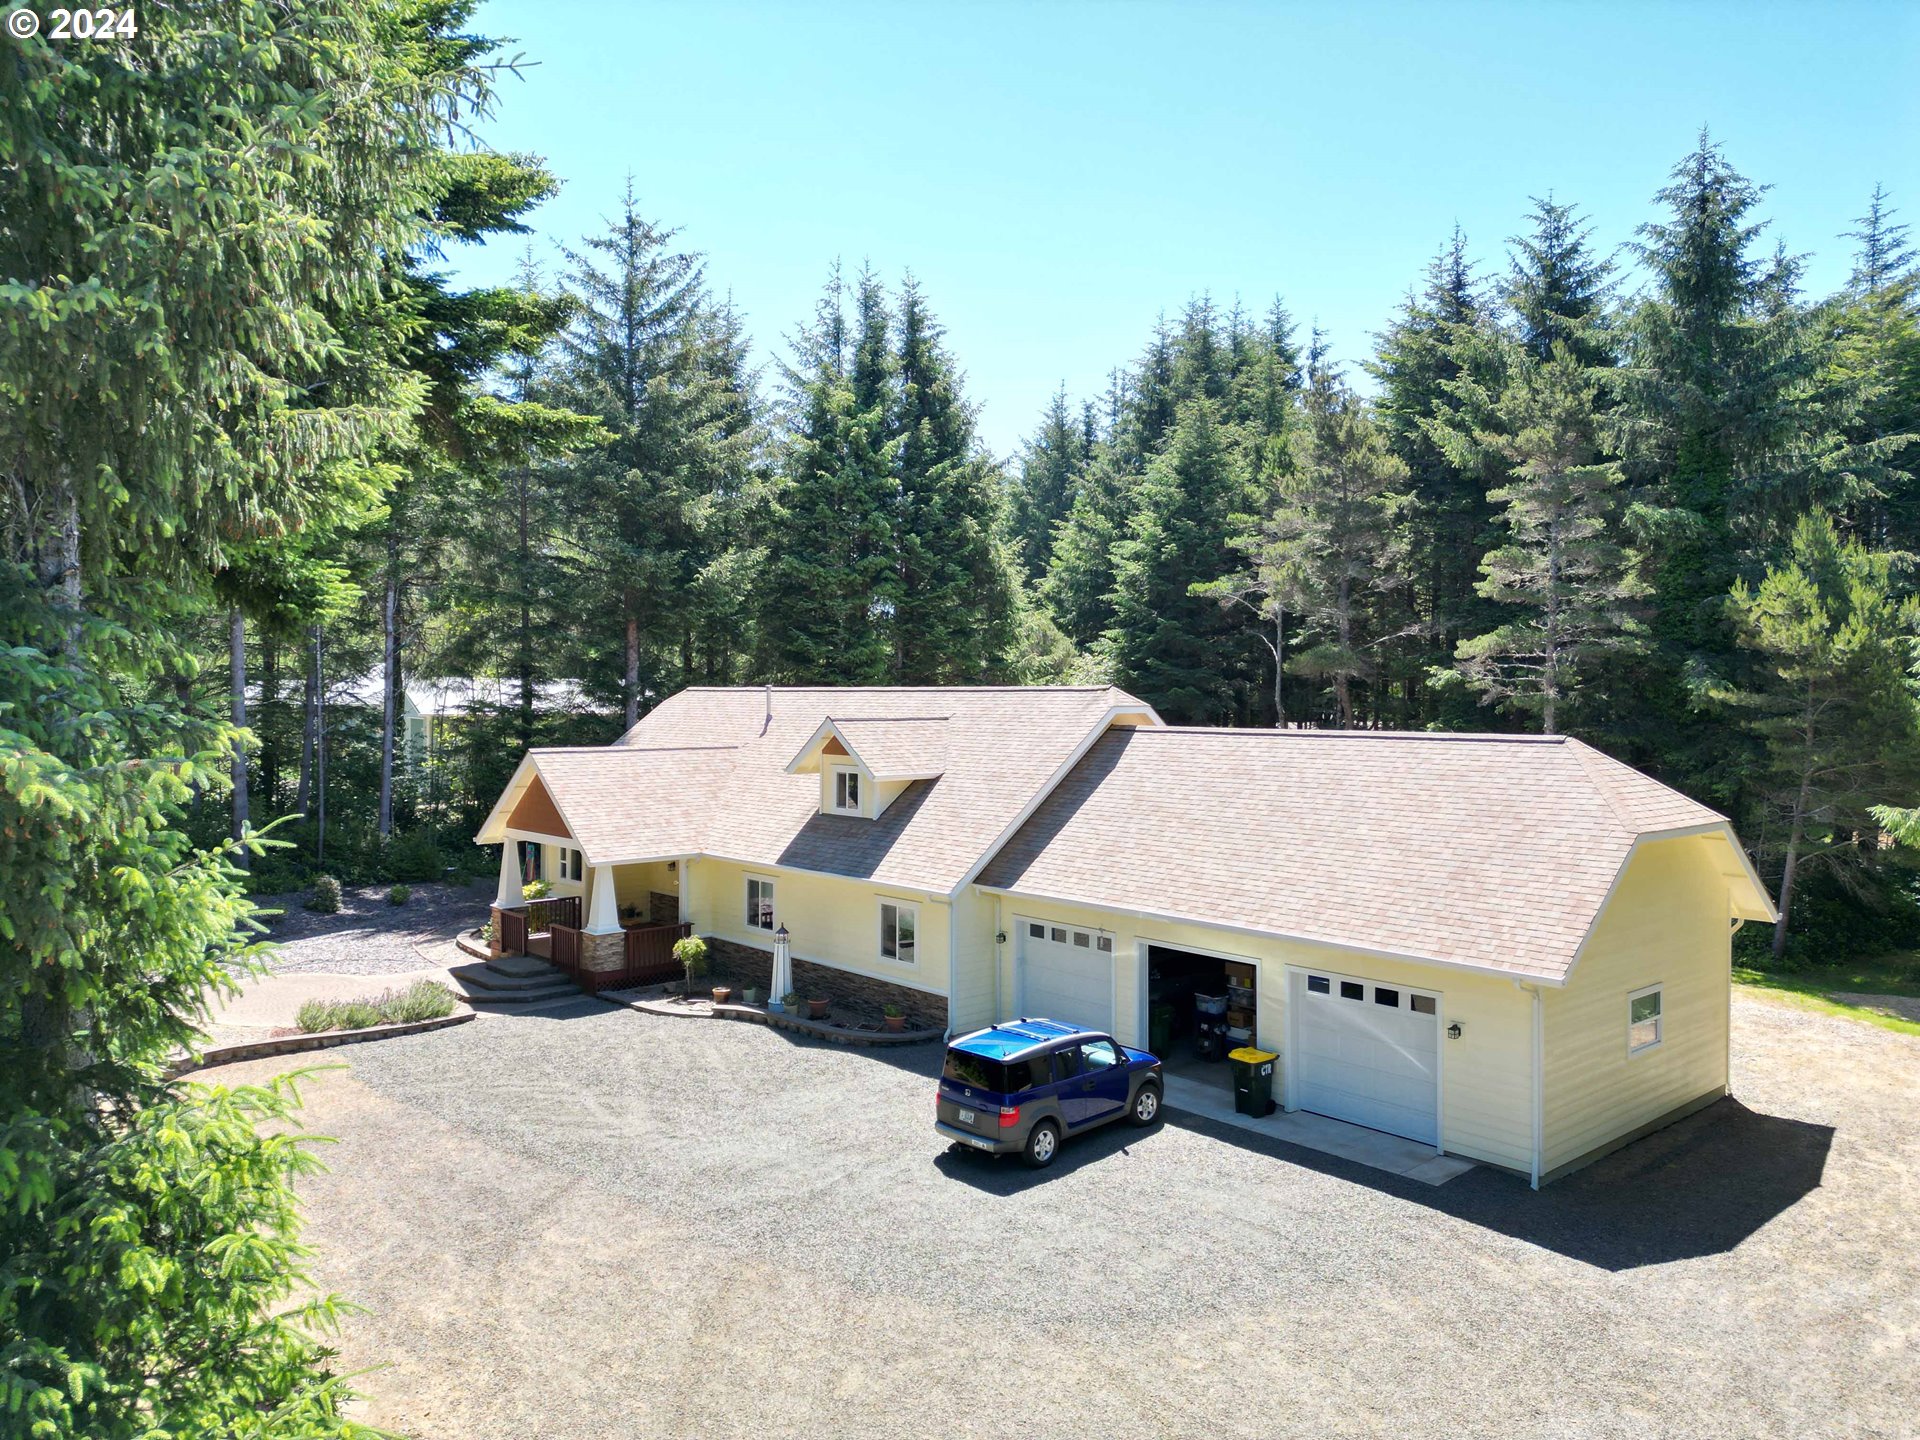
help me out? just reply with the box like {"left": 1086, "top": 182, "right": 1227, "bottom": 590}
{"left": 1459, "top": 340, "right": 1645, "bottom": 735}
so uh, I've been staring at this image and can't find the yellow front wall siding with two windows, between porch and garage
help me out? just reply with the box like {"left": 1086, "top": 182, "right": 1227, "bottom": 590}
{"left": 698, "top": 858, "right": 950, "bottom": 995}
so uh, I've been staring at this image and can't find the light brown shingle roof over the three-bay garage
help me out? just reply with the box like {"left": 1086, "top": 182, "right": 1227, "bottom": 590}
{"left": 979, "top": 728, "right": 1722, "bottom": 981}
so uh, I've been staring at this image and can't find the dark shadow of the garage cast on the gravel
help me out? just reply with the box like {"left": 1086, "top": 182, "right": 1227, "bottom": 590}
{"left": 1167, "top": 1098, "right": 1834, "bottom": 1271}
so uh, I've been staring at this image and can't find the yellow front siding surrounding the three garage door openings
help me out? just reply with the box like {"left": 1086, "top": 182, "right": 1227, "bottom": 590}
{"left": 975, "top": 895, "right": 1532, "bottom": 1171}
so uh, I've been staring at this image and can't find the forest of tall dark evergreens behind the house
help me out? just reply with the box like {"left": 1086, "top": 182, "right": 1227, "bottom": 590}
{"left": 202, "top": 134, "right": 1920, "bottom": 962}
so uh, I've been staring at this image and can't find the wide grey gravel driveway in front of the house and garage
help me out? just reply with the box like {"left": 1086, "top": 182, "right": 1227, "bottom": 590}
{"left": 232, "top": 998, "right": 1920, "bottom": 1440}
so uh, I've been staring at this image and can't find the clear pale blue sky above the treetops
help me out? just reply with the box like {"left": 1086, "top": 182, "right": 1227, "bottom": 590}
{"left": 455, "top": 0, "right": 1920, "bottom": 455}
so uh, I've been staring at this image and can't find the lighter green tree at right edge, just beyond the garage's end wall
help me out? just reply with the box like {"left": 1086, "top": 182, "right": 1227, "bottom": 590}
{"left": 1728, "top": 513, "right": 1920, "bottom": 960}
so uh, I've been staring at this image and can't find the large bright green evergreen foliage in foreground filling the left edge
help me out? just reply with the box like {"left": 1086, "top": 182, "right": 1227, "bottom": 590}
{"left": 0, "top": 0, "right": 484, "bottom": 1440}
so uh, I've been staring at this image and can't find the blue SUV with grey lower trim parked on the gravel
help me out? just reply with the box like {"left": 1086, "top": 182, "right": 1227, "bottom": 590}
{"left": 933, "top": 1020, "right": 1164, "bottom": 1169}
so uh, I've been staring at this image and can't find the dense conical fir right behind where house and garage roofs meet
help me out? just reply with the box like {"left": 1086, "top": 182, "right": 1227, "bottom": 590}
{"left": 1100, "top": 396, "right": 1246, "bottom": 724}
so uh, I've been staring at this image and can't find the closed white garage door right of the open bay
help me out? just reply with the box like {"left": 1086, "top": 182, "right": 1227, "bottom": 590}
{"left": 1290, "top": 970, "right": 1440, "bottom": 1144}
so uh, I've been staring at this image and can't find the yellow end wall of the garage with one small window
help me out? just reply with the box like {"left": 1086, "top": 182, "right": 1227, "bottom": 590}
{"left": 1546, "top": 837, "right": 1732, "bottom": 1171}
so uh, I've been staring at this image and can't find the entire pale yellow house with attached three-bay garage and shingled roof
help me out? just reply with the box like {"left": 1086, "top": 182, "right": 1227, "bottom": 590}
{"left": 478, "top": 687, "right": 1774, "bottom": 1185}
